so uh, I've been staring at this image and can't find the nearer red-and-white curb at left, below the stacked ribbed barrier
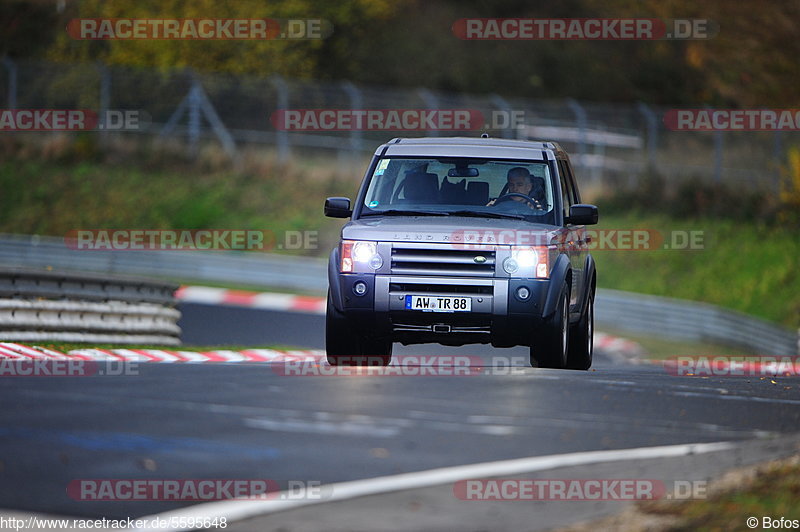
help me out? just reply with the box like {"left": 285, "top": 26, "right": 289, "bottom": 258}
{"left": 0, "top": 342, "right": 325, "bottom": 364}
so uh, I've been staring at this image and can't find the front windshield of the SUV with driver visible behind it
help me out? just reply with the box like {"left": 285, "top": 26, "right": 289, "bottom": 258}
{"left": 361, "top": 158, "right": 556, "bottom": 224}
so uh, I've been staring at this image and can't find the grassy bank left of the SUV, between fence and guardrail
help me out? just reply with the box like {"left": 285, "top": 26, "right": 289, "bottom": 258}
{"left": 0, "top": 140, "right": 357, "bottom": 256}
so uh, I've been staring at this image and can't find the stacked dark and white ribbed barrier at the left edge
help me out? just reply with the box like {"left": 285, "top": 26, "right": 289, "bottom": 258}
{"left": 0, "top": 267, "right": 180, "bottom": 345}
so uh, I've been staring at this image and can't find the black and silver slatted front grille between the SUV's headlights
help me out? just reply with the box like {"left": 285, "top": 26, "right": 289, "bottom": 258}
{"left": 392, "top": 247, "right": 495, "bottom": 277}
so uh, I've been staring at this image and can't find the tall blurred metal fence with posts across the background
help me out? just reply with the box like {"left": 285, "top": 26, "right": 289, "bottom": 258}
{"left": 0, "top": 59, "right": 800, "bottom": 188}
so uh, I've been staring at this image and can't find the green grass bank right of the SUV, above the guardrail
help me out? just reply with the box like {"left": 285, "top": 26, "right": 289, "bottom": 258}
{"left": 592, "top": 215, "right": 800, "bottom": 327}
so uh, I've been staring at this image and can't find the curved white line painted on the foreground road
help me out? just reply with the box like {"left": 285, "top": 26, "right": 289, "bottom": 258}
{"left": 138, "top": 442, "right": 734, "bottom": 532}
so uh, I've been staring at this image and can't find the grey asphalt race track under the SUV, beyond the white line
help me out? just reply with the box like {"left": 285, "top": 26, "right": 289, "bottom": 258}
{"left": 0, "top": 305, "right": 800, "bottom": 528}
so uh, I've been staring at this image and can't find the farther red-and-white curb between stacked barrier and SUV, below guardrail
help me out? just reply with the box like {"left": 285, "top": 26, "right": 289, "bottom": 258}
{"left": 175, "top": 286, "right": 327, "bottom": 314}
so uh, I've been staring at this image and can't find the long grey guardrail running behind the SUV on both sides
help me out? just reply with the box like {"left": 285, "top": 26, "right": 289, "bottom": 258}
{"left": 0, "top": 235, "right": 800, "bottom": 356}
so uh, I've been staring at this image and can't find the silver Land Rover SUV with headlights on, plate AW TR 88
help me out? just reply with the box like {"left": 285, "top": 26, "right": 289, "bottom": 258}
{"left": 325, "top": 138, "right": 598, "bottom": 369}
